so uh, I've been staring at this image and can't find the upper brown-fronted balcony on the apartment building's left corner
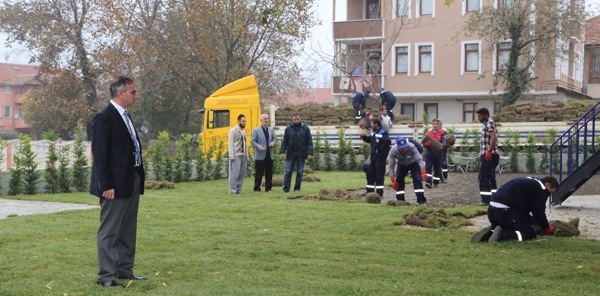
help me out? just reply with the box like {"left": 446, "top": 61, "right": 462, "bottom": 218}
{"left": 333, "top": 19, "right": 383, "bottom": 41}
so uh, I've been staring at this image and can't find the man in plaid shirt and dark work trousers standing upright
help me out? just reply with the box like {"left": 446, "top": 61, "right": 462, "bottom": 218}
{"left": 477, "top": 108, "right": 500, "bottom": 206}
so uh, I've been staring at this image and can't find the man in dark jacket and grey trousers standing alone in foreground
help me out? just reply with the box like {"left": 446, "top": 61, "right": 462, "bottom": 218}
{"left": 90, "top": 76, "right": 145, "bottom": 288}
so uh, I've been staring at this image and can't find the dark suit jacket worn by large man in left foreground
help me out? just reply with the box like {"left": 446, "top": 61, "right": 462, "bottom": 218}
{"left": 90, "top": 103, "right": 145, "bottom": 198}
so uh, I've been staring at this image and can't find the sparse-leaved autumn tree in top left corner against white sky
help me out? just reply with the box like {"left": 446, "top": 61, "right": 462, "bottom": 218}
{"left": 0, "top": 0, "right": 104, "bottom": 131}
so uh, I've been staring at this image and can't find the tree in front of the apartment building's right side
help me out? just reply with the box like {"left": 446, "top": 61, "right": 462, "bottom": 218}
{"left": 464, "top": 0, "right": 586, "bottom": 105}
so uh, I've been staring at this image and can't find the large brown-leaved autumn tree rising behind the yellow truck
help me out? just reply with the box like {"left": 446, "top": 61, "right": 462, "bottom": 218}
{"left": 97, "top": 0, "right": 315, "bottom": 134}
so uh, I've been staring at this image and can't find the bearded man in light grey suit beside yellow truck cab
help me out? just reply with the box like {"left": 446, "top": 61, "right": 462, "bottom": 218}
{"left": 227, "top": 114, "right": 250, "bottom": 194}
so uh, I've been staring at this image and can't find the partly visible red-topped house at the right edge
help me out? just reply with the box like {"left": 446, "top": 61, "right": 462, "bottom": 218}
{"left": 583, "top": 16, "right": 600, "bottom": 99}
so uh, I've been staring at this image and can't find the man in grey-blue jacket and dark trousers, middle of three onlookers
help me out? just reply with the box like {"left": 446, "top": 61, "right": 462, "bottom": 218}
{"left": 252, "top": 114, "right": 275, "bottom": 192}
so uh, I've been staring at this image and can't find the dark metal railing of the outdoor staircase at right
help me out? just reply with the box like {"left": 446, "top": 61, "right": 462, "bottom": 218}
{"left": 550, "top": 102, "right": 600, "bottom": 183}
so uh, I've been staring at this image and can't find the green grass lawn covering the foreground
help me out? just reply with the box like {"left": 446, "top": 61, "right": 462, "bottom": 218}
{"left": 0, "top": 172, "right": 600, "bottom": 295}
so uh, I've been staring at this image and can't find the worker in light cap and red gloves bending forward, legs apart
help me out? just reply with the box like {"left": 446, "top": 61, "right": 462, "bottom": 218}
{"left": 387, "top": 136, "right": 427, "bottom": 206}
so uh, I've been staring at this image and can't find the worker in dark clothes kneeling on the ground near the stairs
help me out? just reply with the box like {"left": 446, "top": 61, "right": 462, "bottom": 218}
{"left": 471, "top": 177, "right": 558, "bottom": 243}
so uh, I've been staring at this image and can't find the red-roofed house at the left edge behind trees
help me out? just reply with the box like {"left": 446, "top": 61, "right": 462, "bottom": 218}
{"left": 0, "top": 63, "right": 42, "bottom": 134}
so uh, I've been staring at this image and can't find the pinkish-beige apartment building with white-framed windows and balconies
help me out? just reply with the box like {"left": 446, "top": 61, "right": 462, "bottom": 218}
{"left": 332, "top": 0, "right": 585, "bottom": 123}
